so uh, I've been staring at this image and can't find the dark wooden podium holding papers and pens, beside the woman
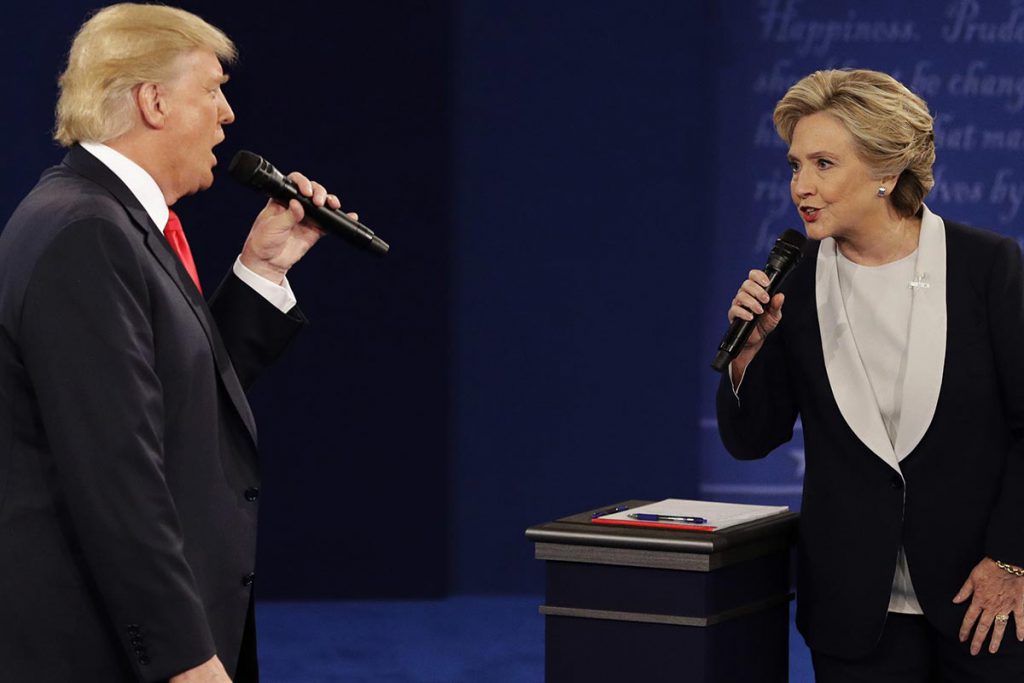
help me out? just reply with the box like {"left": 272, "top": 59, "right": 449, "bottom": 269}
{"left": 526, "top": 501, "right": 799, "bottom": 683}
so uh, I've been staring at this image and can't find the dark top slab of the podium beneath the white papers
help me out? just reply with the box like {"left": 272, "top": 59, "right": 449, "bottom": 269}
{"left": 526, "top": 500, "right": 800, "bottom": 555}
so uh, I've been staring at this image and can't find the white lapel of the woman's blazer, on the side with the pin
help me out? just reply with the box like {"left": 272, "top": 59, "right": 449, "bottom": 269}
{"left": 895, "top": 207, "right": 946, "bottom": 460}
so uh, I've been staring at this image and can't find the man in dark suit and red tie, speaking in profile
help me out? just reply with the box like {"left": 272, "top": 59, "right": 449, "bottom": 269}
{"left": 0, "top": 5, "right": 348, "bottom": 683}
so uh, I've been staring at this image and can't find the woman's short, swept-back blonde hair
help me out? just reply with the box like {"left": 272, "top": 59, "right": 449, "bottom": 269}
{"left": 774, "top": 69, "right": 935, "bottom": 216}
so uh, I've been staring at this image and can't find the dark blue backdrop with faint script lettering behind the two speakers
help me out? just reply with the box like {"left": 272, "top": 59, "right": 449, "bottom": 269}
{"left": 0, "top": 0, "right": 1024, "bottom": 597}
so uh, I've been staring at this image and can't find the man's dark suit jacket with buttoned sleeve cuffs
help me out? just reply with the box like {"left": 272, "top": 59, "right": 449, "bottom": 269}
{"left": 0, "top": 146, "right": 304, "bottom": 682}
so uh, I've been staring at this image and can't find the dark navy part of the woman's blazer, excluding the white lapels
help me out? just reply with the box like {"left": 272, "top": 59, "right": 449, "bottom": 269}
{"left": 717, "top": 216, "right": 1024, "bottom": 657}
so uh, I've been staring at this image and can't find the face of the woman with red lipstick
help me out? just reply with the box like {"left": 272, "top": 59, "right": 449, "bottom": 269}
{"left": 788, "top": 112, "right": 889, "bottom": 241}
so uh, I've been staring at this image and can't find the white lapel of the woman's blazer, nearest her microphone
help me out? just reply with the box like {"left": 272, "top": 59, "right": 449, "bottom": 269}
{"left": 814, "top": 238, "right": 900, "bottom": 472}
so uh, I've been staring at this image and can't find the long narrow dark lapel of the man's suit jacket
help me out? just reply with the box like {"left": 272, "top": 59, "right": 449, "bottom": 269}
{"left": 65, "top": 145, "right": 256, "bottom": 443}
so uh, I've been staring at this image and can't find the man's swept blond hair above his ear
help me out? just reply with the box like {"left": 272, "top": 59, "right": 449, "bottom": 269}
{"left": 53, "top": 3, "right": 238, "bottom": 146}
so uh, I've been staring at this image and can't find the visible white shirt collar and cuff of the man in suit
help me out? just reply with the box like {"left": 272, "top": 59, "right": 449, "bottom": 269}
{"left": 81, "top": 142, "right": 297, "bottom": 313}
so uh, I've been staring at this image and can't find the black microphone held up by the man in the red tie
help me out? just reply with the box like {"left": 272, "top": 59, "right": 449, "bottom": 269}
{"left": 227, "top": 150, "right": 390, "bottom": 256}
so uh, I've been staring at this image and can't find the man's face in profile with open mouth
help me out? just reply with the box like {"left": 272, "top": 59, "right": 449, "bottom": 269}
{"left": 160, "top": 49, "right": 234, "bottom": 197}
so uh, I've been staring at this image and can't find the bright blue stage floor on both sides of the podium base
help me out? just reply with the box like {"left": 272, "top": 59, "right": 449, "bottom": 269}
{"left": 251, "top": 596, "right": 813, "bottom": 683}
